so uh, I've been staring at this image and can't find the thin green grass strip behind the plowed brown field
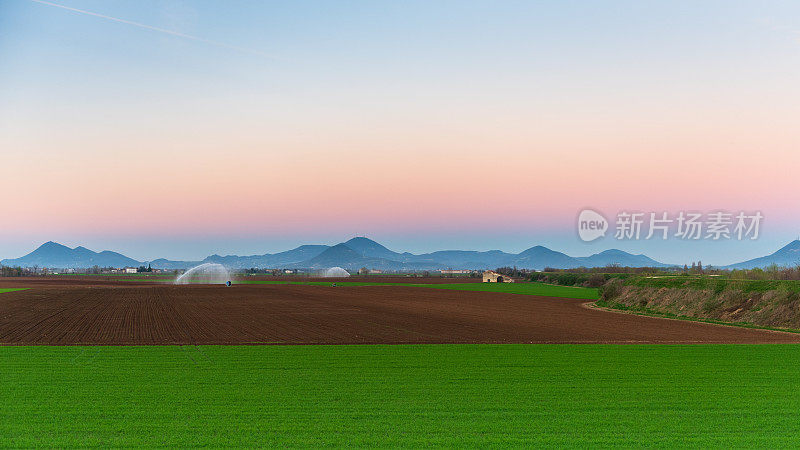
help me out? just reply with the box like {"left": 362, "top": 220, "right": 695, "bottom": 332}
{"left": 237, "top": 280, "right": 599, "bottom": 300}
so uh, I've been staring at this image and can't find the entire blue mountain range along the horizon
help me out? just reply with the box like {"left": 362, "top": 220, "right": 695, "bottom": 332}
{"left": 0, "top": 237, "right": 800, "bottom": 271}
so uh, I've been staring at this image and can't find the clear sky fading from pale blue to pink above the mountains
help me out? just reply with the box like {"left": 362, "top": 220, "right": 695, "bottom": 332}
{"left": 0, "top": 0, "right": 800, "bottom": 264}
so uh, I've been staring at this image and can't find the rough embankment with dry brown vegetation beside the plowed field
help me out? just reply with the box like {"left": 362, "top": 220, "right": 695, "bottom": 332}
{"left": 600, "top": 286, "right": 800, "bottom": 329}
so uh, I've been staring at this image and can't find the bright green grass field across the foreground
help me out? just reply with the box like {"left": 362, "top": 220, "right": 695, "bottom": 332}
{"left": 0, "top": 345, "right": 800, "bottom": 447}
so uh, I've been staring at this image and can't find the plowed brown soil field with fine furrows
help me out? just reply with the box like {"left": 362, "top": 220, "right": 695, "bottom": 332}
{"left": 0, "top": 280, "right": 800, "bottom": 345}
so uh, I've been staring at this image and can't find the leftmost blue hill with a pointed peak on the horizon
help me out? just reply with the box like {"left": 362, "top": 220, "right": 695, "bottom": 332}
{"left": 0, "top": 241, "right": 141, "bottom": 269}
